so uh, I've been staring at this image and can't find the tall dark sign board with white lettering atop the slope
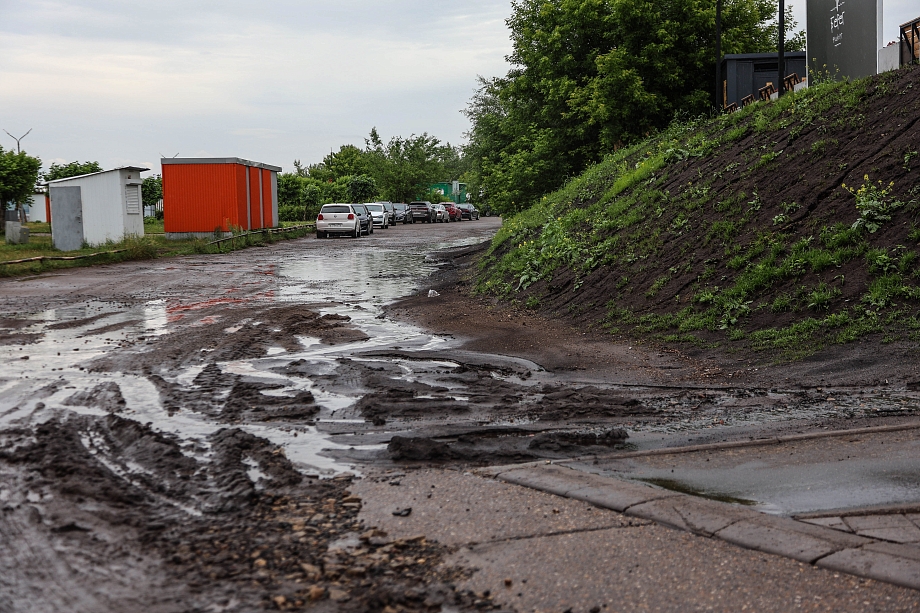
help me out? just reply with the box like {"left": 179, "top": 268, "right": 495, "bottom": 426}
{"left": 806, "top": 0, "right": 882, "bottom": 78}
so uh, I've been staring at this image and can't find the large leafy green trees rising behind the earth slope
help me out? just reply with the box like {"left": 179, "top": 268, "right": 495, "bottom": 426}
{"left": 464, "top": 0, "right": 805, "bottom": 213}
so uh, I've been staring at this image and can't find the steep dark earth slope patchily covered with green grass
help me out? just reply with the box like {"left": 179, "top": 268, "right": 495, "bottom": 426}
{"left": 477, "top": 68, "right": 920, "bottom": 358}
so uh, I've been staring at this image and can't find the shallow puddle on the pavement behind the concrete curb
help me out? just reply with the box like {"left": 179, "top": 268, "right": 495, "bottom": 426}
{"left": 583, "top": 430, "right": 920, "bottom": 515}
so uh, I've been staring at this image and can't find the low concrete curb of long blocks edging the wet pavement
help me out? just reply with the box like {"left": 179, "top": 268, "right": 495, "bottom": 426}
{"left": 474, "top": 464, "right": 920, "bottom": 590}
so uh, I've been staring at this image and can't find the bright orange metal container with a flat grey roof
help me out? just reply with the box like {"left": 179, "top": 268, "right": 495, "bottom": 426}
{"left": 160, "top": 158, "right": 281, "bottom": 238}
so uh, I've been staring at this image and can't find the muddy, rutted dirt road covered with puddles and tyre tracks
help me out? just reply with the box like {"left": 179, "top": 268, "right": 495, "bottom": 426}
{"left": 0, "top": 218, "right": 918, "bottom": 611}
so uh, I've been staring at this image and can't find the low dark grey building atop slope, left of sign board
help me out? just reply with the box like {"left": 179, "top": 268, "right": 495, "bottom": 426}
{"left": 722, "top": 51, "right": 807, "bottom": 108}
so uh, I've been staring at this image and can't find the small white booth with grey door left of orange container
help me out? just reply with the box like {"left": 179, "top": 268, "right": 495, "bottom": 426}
{"left": 46, "top": 166, "right": 150, "bottom": 251}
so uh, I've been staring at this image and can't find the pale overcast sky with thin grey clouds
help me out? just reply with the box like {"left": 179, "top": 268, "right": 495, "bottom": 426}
{"left": 0, "top": 0, "right": 920, "bottom": 171}
